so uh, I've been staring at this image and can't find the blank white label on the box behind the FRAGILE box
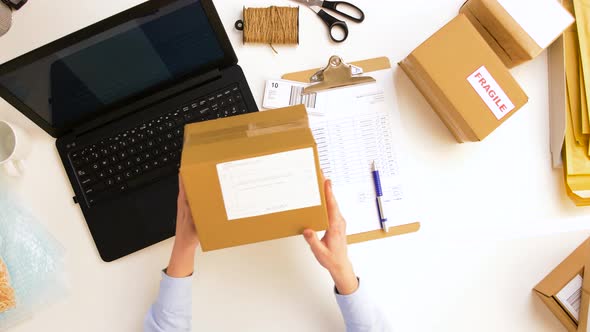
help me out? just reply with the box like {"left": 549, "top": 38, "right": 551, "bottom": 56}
{"left": 498, "top": 0, "right": 574, "bottom": 49}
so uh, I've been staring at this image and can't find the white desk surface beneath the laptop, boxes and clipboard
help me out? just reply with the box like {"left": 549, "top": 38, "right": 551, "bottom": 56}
{"left": 0, "top": 0, "right": 590, "bottom": 332}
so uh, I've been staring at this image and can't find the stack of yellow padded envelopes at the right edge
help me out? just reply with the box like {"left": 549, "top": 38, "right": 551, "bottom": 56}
{"left": 562, "top": 0, "right": 590, "bottom": 206}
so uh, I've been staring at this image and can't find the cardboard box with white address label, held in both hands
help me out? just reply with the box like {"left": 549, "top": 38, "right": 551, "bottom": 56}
{"left": 180, "top": 105, "right": 328, "bottom": 251}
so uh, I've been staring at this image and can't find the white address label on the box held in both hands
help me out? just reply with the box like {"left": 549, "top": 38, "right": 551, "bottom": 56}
{"left": 217, "top": 148, "right": 322, "bottom": 220}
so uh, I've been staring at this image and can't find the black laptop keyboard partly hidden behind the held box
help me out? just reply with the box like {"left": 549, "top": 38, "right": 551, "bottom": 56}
{"left": 69, "top": 84, "right": 248, "bottom": 206}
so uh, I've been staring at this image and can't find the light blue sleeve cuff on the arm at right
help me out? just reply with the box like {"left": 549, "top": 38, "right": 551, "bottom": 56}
{"left": 334, "top": 280, "right": 392, "bottom": 332}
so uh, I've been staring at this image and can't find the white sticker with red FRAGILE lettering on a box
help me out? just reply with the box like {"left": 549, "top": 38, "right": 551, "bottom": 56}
{"left": 467, "top": 66, "right": 514, "bottom": 120}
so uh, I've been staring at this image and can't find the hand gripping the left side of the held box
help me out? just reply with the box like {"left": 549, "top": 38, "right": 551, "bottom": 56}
{"left": 166, "top": 175, "right": 199, "bottom": 278}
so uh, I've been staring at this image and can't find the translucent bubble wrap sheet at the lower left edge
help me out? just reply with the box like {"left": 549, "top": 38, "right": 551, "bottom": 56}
{"left": 0, "top": 175, "right": 65, "bottom": 331}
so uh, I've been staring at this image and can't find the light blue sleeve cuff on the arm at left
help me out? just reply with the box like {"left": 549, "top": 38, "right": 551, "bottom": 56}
{"left": 144, "top": 272, "right": 192, "bottom": 332}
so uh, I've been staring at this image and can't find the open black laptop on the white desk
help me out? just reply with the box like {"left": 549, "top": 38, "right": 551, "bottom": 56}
{"left": 0, "top": 0, "right": 258, "bottom": 262}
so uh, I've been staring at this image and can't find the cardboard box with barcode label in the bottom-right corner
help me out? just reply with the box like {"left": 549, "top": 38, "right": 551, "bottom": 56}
{"left": 533, "top": 239, "right": 590, "bottom": 332}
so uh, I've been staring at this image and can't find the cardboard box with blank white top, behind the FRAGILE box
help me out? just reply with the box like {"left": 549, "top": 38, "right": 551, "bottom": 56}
{"left": 460, "top": 0, "right": 574, "bottom": 68}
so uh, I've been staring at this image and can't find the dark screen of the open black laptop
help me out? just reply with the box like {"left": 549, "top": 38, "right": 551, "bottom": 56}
{"left": 0, "top": 0, "right": 224, "bottom": 127}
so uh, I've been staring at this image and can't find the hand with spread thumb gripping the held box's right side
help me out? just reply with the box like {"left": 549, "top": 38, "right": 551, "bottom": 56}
{"left": 303, "top": 180, "right": 358, "bottom": 295}
